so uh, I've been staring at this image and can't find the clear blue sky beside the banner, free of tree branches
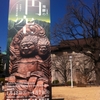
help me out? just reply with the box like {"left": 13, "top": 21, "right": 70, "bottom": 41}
{"left": 0, "top": 0, "right": 67, "bottom": 52}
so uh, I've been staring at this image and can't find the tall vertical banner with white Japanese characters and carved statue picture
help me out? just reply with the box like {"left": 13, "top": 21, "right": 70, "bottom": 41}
{"left": 5, "top": 0, "right": 51, "bottom": 100}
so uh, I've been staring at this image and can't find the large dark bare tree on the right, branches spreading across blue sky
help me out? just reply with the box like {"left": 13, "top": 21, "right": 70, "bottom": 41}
{"left": 52, "top": 0, "right": 100, "bottom": 85}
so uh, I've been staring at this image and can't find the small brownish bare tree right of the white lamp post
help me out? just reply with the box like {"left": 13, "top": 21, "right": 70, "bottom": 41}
{"left": 73, "top": 54, "right": 95, "bottom": 84}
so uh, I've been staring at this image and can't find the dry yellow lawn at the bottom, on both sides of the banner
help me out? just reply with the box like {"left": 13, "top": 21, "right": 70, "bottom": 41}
{"left": 0, "top": 86, "right": 100, "bottom": 100}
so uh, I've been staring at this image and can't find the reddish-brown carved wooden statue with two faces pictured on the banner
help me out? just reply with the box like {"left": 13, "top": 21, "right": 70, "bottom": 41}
{"left": 5, "top": 23, "right": 51, "bottom": 100}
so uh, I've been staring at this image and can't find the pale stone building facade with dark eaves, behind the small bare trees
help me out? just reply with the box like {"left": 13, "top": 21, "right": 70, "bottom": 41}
{"left": 51, "top": 46, "right": 95, "bottom": 84}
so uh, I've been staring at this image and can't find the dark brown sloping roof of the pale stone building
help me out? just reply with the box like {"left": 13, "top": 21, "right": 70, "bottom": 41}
{"left": 51, "top": 38, "right": 94, "bottom": 52}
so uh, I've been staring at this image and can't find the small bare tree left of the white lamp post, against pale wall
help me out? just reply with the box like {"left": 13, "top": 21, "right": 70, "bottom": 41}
{"left": 52, "top": 55, "right": 70, "bottom": 85}
